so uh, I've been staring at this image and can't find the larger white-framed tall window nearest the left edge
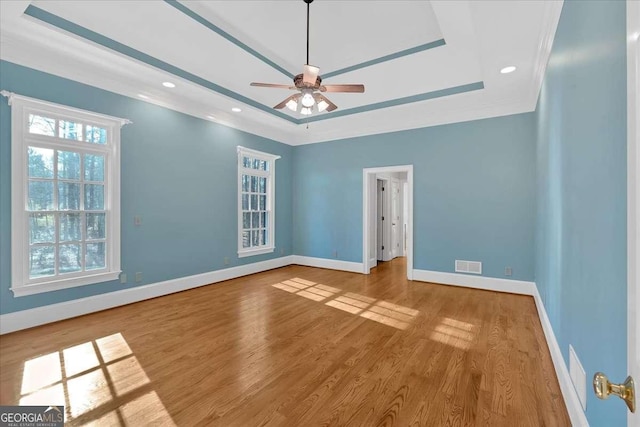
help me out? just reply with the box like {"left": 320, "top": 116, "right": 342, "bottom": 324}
{"left": 4, "top": 93, "right": 126, "bottom": 296}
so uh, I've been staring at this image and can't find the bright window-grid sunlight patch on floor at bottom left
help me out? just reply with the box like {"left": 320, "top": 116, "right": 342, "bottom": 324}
{"left": 19, "top": 333, "right": 175, "bottom": 425}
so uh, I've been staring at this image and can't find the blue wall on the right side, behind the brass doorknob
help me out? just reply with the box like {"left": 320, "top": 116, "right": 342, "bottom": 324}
{"left": 536, "top": 1, "right": 627, "bottom": 427}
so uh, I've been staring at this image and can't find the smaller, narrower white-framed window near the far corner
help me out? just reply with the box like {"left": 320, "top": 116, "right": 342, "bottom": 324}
{"left": 238, "top": 147, "right": 280, "bottom": 258}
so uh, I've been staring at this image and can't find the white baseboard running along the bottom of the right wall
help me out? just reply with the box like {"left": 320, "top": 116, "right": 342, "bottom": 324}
{"left": 533, "top": 287, "right": 589, "bottom": 427}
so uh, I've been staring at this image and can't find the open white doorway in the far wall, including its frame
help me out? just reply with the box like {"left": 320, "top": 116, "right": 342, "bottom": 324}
{"left": 362, "top": 165, "right": 413, "bottom": 280}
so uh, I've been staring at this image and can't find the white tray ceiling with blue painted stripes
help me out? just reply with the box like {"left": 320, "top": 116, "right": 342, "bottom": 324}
{"left": 0, "top": 0, "right": 562, "bottom": 145}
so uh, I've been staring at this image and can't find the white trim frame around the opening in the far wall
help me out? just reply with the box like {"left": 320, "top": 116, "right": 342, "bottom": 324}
{"left": 362, "top": 165, "right": 413, "bottom": 280}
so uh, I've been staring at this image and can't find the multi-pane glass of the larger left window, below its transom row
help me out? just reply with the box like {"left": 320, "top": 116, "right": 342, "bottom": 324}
{"left": 26, "top": 149, "right": 110, "bottom": 279}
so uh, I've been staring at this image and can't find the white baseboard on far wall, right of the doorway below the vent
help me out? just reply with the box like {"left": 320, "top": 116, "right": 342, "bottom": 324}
{"left": 413, "top": 270, "right": 536, "bottom": 295}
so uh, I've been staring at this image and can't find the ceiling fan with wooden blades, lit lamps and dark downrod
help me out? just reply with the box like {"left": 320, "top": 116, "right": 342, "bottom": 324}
{"left": 251, "top": 0, "right": 364, "bottom": 115}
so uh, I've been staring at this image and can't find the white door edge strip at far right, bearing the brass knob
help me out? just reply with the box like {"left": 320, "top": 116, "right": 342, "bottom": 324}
{"left": 627, "top": 0, "right": 640, "bottom": 427}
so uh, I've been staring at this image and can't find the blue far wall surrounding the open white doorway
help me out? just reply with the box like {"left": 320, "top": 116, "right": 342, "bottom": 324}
{"left": 293, "top": 113, "right": 535, "bottom": 281}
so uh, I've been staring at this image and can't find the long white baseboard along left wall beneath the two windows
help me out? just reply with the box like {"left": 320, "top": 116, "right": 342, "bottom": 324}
{"left": 0, "top": 255, "right": 294, "bottom": 335}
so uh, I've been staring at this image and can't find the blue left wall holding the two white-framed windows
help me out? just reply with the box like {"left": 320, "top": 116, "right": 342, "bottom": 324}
{"left": 0, "top": 61, "right": 293, "bottom": 314}
